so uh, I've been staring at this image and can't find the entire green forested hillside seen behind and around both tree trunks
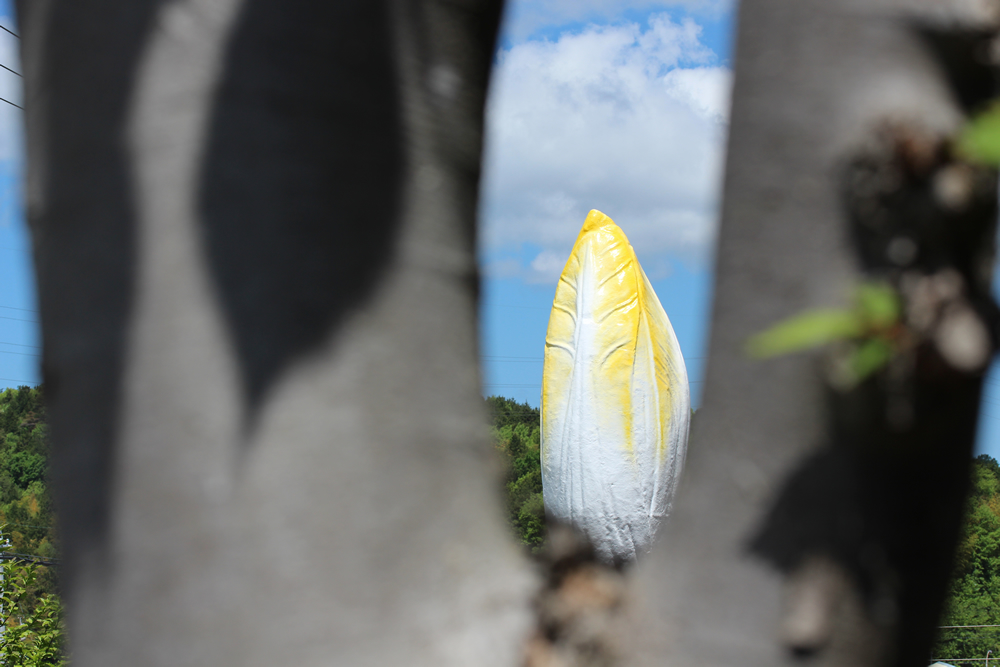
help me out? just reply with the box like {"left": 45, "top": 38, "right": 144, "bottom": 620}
{"left": 0, "top": 387, "right": 1000, "bottom": 665}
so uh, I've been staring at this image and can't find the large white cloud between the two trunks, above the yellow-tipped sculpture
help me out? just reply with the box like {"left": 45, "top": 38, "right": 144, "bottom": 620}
{"left": 481, "top": 14, "right": 730, "bottom": 282}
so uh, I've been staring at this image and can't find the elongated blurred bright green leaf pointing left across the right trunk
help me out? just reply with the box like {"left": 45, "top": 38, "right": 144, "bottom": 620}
{"left": 747, "top": 309, "right": 864, "bottom": 359}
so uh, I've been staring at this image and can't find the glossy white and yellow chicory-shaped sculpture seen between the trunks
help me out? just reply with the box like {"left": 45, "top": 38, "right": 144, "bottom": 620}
{"left": 541, "top": 211, "right": 691, "bottom": 563}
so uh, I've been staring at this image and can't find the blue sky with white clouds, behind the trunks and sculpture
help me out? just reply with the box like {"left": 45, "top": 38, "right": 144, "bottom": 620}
{"left": 0, "top": 0, "right": 1000, "bottom": 459}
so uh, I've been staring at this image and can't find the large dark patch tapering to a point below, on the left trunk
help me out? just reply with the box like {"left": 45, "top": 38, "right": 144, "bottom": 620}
{"left": 200, "top": 0, "right": 404, "bottom": 419}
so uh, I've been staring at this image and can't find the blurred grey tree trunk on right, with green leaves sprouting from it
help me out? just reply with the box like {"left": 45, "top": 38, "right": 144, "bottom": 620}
{"left": 622, "top": 0, "right": 997, "bottom": 667}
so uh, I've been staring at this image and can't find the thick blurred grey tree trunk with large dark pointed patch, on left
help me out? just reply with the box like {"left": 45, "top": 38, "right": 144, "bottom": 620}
{"left": 20, "top": 0, "right": 531, "bottom": 667}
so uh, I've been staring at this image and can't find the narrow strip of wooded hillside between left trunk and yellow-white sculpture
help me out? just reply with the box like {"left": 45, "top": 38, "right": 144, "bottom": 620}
{"left": 486, "top": 396, "right": 545, "bottom": 552}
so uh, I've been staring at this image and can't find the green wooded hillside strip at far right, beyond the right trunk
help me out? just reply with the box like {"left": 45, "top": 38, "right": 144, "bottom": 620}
{"left": 928, "top": 454, "right": 1000, "bottom": 659}
